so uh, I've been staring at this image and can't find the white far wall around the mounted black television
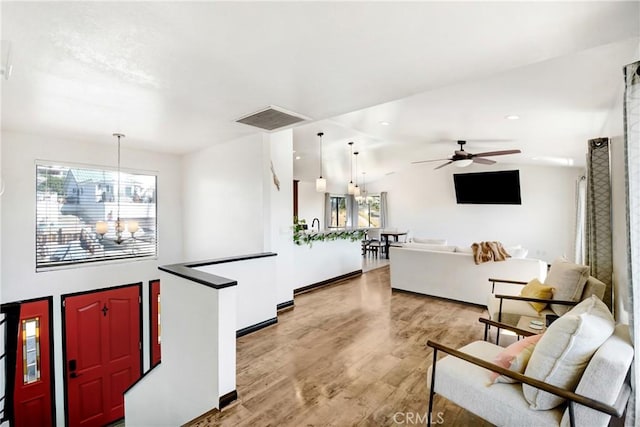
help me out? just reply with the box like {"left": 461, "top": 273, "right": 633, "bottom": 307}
{"left": 368, "top": 165, "right": 581, "bottom": 262}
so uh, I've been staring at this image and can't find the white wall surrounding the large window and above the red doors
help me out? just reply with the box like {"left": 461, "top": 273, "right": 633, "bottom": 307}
{"left": 1, "top": 132, "right": 182, "bottom": 425}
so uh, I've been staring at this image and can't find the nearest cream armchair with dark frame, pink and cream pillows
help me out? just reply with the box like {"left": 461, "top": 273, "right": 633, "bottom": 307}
{"left": 427, "top": 297, "right": 634, "bottom": 427}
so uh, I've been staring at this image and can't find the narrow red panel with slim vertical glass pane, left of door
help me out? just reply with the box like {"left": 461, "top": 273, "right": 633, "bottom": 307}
{"left": 13, "top": 300, "right": 53, "bottom": 426}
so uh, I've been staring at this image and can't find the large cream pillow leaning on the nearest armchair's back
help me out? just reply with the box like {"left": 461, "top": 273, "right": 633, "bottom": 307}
{"left": 522, "top": 296, "right": 615, "bottom": 411}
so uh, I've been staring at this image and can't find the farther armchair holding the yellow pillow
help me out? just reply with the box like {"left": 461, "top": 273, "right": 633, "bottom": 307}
{"left": 487, "top": 260, "right": 606, "bottom": 338}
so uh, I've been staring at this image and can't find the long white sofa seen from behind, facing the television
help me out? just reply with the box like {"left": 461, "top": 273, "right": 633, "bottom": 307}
{"left": 389, "top": 245, "right": 547, "bottom": 306}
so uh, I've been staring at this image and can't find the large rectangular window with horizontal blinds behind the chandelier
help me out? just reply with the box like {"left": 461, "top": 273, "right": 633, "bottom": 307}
{"left": 36, "top": 165, "right": 156, "bottom": 268}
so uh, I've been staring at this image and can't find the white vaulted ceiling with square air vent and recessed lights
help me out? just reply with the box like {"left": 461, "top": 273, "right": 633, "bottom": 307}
{"left": 0, "top": 1, "right": 640, "bottom": 186}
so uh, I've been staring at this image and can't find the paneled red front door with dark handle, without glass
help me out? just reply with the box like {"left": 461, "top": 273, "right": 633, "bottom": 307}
{"left": 63, "top": 285, "right": 141, "bottom": 427}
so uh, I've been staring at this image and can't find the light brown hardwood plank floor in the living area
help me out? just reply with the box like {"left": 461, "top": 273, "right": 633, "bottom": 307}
{"left": 188, "top": 267, "right": 490, "bottom": 427}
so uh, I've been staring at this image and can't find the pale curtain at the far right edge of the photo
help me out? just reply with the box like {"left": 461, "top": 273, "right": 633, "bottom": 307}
{"left": 624, "top": 62, "right": 640, "bottom": 426}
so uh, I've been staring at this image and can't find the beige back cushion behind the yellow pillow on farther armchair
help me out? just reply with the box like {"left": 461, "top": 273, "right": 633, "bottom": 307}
{"left": 544, "top": 258, "right": 590, "bottom": 316}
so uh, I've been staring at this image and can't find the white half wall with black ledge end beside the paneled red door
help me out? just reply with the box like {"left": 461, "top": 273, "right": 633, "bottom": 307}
{"left": 125, "top": 273, "right": 236, "bottom": 427}
